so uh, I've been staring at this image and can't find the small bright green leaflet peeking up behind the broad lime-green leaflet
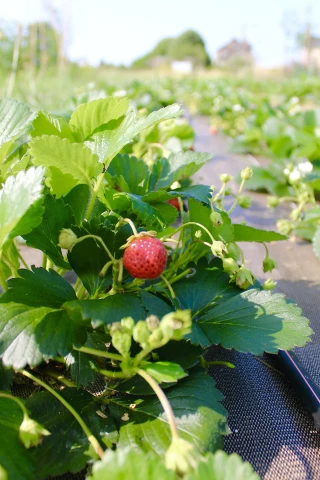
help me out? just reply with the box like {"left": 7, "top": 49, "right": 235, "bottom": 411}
{"left": 31, "top": 111, "right": 75, "bottom": 142}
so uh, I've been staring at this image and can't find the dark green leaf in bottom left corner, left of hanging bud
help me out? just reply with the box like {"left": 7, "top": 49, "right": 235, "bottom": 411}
{"left": 0, "top": 398, "right": 36, "bottom": 480}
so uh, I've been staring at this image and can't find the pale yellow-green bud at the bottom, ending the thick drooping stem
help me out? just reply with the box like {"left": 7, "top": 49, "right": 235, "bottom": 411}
{"left": 165, "top": 437, "right": 200, "bottom": 476}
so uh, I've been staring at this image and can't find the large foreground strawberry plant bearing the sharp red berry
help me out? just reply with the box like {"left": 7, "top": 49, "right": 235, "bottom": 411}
{"left": 0, "top": 97, "right": 312, "bottom": 480}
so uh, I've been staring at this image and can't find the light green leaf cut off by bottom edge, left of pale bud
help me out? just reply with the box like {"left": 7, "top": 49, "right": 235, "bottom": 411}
{"left": 88, "top": 448, "right": 176, "bottom": 480}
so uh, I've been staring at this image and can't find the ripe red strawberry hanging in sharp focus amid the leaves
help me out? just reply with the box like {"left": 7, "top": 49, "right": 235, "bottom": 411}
{"left": 123, "top": 235, "right": 167, "bottom": 279}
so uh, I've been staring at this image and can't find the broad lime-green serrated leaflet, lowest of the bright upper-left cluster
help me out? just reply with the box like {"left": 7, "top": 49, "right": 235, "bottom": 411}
{"left": 30, "top": 135, "right": 102, "bottom": 195}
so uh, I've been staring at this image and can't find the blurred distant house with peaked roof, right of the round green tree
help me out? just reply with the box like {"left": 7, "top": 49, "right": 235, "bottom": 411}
{"left": 216, "top": 39, "right": 254, "bottom": 66}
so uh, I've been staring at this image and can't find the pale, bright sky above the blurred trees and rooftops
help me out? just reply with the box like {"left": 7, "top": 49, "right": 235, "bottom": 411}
{"left": 0, "top": 0, "right": 320, "bottom": 67}
